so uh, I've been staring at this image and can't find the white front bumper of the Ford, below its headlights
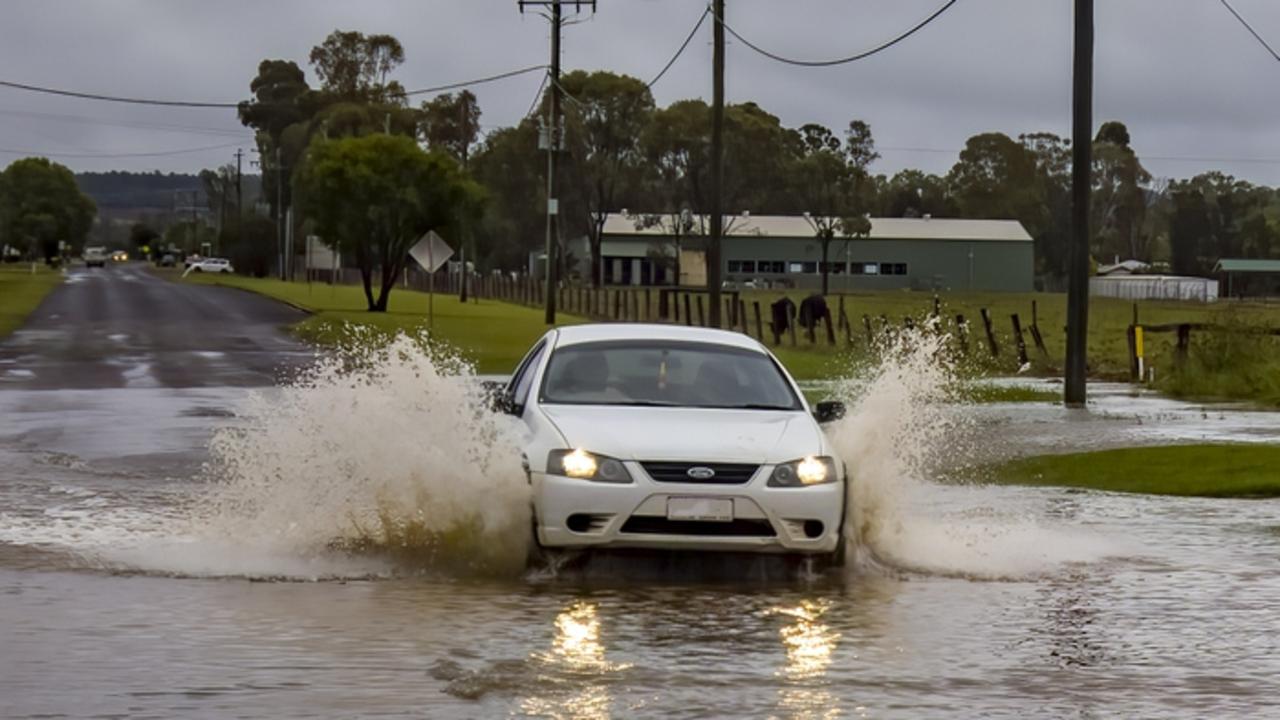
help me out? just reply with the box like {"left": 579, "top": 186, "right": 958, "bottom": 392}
{"left": 530, "top": 461, "right": 845, "bottom": 553}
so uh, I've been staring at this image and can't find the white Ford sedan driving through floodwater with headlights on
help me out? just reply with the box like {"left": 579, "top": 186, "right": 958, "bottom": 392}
{"left": 497, "top": 324, "right": 846, "bottom": 564}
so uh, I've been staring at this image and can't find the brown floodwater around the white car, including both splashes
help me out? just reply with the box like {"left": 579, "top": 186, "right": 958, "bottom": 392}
{"left": 0, "top": 338, "right": 1280, "bottom": 719}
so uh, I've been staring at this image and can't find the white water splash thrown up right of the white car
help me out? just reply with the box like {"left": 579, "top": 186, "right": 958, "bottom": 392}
{"left": 828, "top": 325, "right": 1110, "bottom": 579}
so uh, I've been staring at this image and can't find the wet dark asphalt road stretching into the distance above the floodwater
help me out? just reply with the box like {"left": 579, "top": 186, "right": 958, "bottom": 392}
{"left": 0, "top": 263, "right": 310, "bottom": 389}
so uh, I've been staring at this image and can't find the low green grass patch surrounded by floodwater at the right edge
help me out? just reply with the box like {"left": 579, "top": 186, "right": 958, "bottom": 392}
{"left": 970, "top": 445, "right": 1280, "bottom": 497}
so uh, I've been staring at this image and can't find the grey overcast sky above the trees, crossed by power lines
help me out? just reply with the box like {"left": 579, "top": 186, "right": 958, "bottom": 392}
{"left": 0, "top": 0, "right": 1280, "bottom": 184}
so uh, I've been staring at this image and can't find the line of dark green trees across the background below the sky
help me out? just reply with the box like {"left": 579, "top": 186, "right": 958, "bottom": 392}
{"left": 0, "top": 31, "right": 1280, "bottom": 298}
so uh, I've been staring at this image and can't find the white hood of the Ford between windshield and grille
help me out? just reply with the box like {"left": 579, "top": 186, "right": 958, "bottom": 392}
{"left": 541, "top": 405, "right": 826, "bottom": 464}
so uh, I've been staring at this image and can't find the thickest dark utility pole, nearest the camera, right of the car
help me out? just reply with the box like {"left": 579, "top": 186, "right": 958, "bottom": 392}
{"left": 1062, "top": 0, "right": 1093, "bottom": 407}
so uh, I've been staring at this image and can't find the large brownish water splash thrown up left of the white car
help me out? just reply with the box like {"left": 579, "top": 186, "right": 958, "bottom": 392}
{"left": 196, "top": 334, "right": 530, "bottom": 573}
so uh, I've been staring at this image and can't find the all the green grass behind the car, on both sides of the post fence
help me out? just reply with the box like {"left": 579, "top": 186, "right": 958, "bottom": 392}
{"left": 180, "top": 275, "right": 1280, "bottom": 389}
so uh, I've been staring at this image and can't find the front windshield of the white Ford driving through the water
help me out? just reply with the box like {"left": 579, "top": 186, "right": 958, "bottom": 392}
{"left": 541, "top": 341, "right": 803, "bottom": 410}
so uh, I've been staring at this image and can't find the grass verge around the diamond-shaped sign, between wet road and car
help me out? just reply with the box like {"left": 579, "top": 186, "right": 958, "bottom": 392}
{"left": 183, "top": 273, "right": 582, "bottom": 373}
